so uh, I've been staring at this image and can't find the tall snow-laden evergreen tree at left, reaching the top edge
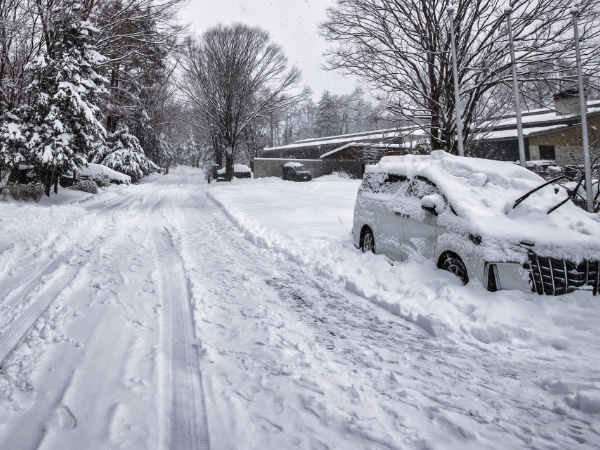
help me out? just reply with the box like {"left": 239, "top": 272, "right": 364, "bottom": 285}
{"left": 19, "top": 0, "right": 105, "bottom": 195}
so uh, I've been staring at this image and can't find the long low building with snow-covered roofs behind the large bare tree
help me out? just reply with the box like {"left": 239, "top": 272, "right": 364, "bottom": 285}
{"left": 254, "top": 96, "right": 600, "bottom": 178}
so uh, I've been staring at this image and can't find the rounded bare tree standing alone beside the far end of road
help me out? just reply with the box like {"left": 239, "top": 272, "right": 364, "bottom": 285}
{"left": 181, "top": 24, "right": 303, "bottom": 179}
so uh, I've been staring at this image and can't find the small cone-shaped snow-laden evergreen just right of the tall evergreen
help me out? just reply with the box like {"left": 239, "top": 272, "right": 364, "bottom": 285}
{"left": 91, "top": 125, "right": 160, "bottom": 182}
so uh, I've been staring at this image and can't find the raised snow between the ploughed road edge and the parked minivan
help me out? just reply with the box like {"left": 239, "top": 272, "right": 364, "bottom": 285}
{"left": 208, "top": 174, "right": 600, "bottom": 355}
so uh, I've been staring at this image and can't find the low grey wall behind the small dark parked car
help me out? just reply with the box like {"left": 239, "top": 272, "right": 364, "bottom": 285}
{"left": 254, "top": 158, "right": 364, "bottom": 178}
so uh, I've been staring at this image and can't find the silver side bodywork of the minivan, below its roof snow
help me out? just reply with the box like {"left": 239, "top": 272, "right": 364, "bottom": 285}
{"left": 352, "top": 174, "right": 531, "bottom": 293}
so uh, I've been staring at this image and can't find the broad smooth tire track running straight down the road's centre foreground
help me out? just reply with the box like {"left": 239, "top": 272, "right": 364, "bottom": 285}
{"left": 153, "top": 228, "right": 210, "bottom": 450}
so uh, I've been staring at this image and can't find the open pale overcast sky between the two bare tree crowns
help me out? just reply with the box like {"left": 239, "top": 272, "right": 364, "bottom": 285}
{"left": 181, "top": 0, "right": 357, "bottom": 99}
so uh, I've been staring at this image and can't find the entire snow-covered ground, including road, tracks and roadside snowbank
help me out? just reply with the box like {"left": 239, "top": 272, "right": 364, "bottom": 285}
{"left": 0, "top": 167, "right": 600, "bottom": 449}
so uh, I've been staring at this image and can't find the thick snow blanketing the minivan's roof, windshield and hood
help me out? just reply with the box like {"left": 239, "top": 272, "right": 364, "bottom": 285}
{"left": 366, "top": 150, "right": 600, "bottom": 259}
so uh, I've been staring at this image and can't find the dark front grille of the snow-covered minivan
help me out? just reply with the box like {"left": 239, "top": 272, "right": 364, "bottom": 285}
{"left": 529, "top": 250, "right": 600, "bottom": 295}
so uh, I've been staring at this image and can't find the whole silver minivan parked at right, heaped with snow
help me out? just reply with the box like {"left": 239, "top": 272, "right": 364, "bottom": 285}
{"left": 352, "top": 151, "right": 600, "bottom": 295}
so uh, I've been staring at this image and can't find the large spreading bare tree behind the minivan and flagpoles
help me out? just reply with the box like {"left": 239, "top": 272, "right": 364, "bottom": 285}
{"left": 321, "top": 0, "right": 600, "bottom": 151}
